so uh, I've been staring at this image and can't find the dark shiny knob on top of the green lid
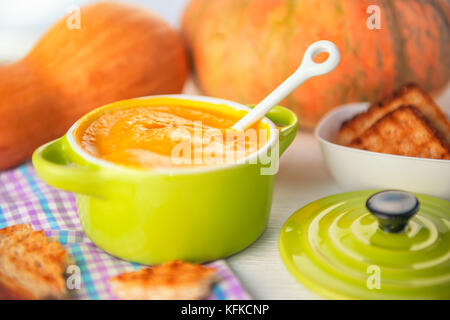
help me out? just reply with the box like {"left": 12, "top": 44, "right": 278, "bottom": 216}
{"left": 366, "top": 190, "right": 419, "bottom": 232}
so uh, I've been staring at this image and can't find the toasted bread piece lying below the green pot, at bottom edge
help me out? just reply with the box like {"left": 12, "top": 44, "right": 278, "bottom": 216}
{"left": 110, "top": 260, "right": 216, "bottom": 300}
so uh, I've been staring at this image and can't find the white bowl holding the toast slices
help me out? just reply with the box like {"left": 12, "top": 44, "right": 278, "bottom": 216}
{"left": 315, "top": 103, "right": 450, "bottom": 200}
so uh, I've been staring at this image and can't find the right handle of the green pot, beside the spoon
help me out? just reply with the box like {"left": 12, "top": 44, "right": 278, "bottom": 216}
{"left": 253, "top": 106, "right": 298, "bottom": 156}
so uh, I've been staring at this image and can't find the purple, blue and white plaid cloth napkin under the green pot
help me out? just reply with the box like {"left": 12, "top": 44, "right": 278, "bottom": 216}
{"left": 0, "top": 163, "right": 249, "bottom": 300}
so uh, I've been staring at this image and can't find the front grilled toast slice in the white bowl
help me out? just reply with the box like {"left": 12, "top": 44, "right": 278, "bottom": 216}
{"left": 349, "top": 106, "right": 450, "bottom": 159}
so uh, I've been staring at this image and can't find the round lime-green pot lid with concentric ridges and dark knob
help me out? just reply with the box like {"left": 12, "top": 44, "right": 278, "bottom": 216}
{"left": 279, "top": 191, "right": 450, "bottom": 299}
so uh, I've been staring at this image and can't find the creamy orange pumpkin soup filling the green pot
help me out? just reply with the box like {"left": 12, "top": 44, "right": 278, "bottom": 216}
{"left": 78, "top": 106, "right": 269, "bottom": 168}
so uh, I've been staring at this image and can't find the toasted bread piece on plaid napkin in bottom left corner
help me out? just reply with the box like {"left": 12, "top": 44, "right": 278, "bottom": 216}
{"left": 0, "top": 225, "right": 67, "bottom": 299}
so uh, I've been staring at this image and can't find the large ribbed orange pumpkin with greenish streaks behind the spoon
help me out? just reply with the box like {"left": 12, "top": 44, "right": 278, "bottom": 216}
{"left": 182, "top": 0, "right": 450, "bottom": 127}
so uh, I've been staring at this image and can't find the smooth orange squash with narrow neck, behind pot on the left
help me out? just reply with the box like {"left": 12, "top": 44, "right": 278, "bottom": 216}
{"left": 0, "top": 2, "right": 188, "bottom": 170}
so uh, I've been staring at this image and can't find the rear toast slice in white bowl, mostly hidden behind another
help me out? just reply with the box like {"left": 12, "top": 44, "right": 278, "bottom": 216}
{"left": 336, "top": 84, "right": 450, "bottom": 145}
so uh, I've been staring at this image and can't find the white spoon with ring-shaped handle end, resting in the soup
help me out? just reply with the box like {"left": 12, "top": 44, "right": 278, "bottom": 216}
{"left": 233, "top": 40, "right": 340, "bottom": 130}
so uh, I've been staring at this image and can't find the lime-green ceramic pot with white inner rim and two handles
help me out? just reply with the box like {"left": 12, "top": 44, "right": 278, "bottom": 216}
{"left": 33, "top": 95, "right": 298, "bottom": 264}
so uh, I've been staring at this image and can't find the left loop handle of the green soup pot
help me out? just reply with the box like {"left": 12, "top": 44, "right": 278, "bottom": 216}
{"left": 32, "top": 136, "right": 107, "bottom": 198}
